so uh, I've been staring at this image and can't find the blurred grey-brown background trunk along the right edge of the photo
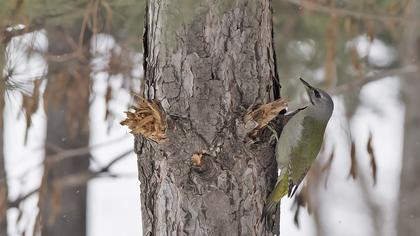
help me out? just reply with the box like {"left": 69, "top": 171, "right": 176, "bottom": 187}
{"left": 397, "top": 1, "right": 420, "bottom": 236}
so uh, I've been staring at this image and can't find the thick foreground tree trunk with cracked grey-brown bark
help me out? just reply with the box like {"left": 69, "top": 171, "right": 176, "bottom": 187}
{"left": 135, "top": 0, "right": 279, "bottom": 235}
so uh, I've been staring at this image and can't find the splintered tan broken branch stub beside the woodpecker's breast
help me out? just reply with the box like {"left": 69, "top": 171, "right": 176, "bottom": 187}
{"left": 244, "top": 98, "right": 287, "bottom": 137}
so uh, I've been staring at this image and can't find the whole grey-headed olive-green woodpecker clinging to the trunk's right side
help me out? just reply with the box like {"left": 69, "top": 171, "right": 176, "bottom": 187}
{"left": 262, "top": 79, "right": 334, "bottom": 223}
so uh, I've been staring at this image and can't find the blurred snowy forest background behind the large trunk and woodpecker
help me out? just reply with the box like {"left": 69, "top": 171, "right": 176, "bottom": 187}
{"left": 0, "top": 0, "right": 420, "bottom": 236}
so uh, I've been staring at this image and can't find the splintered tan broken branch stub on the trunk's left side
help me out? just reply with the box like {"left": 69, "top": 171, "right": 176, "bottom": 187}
{"left": 120, "top": 96, "right": 166, "bottom": 143}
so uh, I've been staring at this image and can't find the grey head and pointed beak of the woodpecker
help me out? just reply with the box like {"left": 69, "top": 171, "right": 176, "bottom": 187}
{"left": 300, "top": 78, "right": 334, "bottom": 120}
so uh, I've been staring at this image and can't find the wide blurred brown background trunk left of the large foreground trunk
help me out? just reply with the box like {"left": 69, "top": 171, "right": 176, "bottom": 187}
{"left": 39, "top": 22, "right": 91, "bottom": 236}
